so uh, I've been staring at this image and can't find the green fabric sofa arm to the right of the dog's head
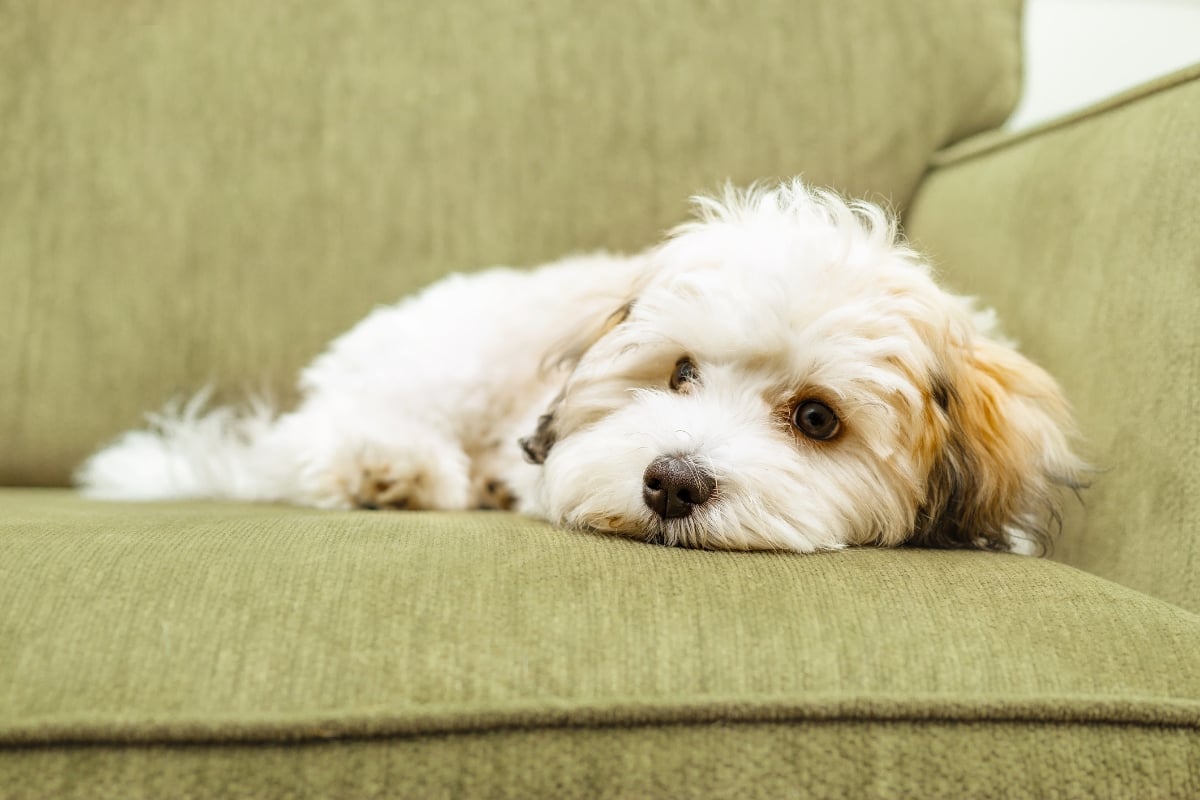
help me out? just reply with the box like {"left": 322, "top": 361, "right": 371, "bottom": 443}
{"left": 908, "top": 67, "right": 1200, "bottom": 614}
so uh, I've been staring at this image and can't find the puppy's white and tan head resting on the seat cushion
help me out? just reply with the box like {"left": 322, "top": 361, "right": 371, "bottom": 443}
{"left": 526, "top": 184, "right": 1081, "bottom": 551}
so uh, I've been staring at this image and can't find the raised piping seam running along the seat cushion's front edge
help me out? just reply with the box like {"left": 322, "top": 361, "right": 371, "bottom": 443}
{"left": 0, "top": 697, "right": 1200, "bottom": 747}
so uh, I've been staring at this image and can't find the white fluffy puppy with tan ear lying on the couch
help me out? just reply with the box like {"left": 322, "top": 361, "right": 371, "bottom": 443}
{"left": 78, "top": 181, "right": 1082, "bottom": 552}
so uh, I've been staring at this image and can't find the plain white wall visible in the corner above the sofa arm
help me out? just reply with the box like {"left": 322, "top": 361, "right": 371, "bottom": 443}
{"left": 1008, "top": 0, "right": 1200, "bottom": 128}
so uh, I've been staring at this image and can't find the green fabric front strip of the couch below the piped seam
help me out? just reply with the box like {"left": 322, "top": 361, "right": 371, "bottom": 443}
{"left": 7, "top": 721, "right": 1200, "bottom": 800}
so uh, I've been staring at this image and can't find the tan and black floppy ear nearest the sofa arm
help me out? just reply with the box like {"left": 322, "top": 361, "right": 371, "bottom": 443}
{"left": 912, "top": 339, "right": 1086, "bottom": 553}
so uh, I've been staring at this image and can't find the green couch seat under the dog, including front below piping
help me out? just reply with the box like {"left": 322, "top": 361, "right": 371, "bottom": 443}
{"left": 0, "top": 489, "right": 1200, "bottom": 798}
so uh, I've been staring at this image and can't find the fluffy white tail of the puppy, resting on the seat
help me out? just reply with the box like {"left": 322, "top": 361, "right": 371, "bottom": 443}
{"left": 76, "top": 390, "right": 282, "bottom": 501}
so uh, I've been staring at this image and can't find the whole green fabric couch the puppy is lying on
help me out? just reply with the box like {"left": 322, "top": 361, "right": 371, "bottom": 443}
{"left": 0, "top": 0, "right": 1200, "bottom": 799}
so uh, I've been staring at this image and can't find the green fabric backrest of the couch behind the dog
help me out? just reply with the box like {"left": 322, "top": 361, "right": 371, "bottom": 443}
{"left": 0, "top": 0, "right": 1020, "bottom": 485}
